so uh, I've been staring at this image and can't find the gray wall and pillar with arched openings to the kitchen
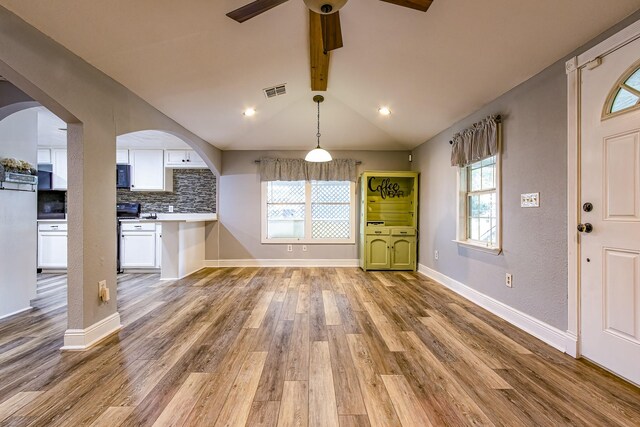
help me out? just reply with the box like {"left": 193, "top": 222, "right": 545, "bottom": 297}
{"left": 0, "top": 7, "right": 221, "bottom": 329}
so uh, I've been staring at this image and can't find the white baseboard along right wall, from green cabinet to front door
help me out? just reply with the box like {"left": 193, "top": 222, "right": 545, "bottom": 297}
{"left": 418, "top": 264, "right": 577, "bottom": 355}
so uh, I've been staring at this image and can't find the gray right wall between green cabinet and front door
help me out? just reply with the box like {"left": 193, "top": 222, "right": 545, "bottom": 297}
{"left": 413, "top": 9, "right": 640, "bottom": 330}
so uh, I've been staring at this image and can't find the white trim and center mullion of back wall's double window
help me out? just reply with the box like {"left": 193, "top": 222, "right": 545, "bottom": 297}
{"left": 260, "top": 181, "right": 356, "bottom": 245}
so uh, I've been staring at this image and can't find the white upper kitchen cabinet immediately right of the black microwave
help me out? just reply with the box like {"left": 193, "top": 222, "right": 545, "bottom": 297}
{"left": 129, "top": 150, "right": 173, "bottom": 191}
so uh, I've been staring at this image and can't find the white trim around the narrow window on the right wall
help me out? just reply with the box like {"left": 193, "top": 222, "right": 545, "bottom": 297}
{"left": 453, "top": 153, "right": 502, "bottom": 255}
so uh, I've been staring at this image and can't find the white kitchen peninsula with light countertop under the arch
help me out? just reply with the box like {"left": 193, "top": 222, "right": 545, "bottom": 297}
{"left": 121, "top": 213, "right": 218, "bottom": 280}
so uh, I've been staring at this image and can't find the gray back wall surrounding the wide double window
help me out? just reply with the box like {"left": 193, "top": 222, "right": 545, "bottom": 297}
{"left": 216, "top": 151, "right": 411, "bottom": 259}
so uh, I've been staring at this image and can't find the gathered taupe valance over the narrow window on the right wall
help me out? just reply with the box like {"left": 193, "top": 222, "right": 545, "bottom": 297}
{"left": 451, "top": 116, "right": 500, "bottom": 167}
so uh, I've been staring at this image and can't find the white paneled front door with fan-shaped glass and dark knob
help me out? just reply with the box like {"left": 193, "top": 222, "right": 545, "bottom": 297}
{"left": 580, "top": 35, "right": 640, "bottom": 384}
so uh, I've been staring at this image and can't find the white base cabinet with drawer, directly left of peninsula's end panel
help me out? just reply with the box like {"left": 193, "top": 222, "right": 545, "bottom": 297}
{"left": 120, "top": 223, "right": 158, "bottom": 268}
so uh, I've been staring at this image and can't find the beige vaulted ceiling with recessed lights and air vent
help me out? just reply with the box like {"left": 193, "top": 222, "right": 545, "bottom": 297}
{"left": 0, "top": 0, "right": 640, "bottom": 150}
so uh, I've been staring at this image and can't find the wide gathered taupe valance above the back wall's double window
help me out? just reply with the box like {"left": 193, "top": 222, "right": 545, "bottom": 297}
{"left": 260, "top": 158, "right": 358, "bottom": 182}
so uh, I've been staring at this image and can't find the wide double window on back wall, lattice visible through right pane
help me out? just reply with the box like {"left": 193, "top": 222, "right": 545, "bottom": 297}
{"left": 262, "top": 181, "right": 355, "bottom": 244}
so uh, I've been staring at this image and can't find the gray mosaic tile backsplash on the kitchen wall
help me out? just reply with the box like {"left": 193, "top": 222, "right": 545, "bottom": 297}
{"left": 117, "top": 169, "right": 216, "bottom": 213}
